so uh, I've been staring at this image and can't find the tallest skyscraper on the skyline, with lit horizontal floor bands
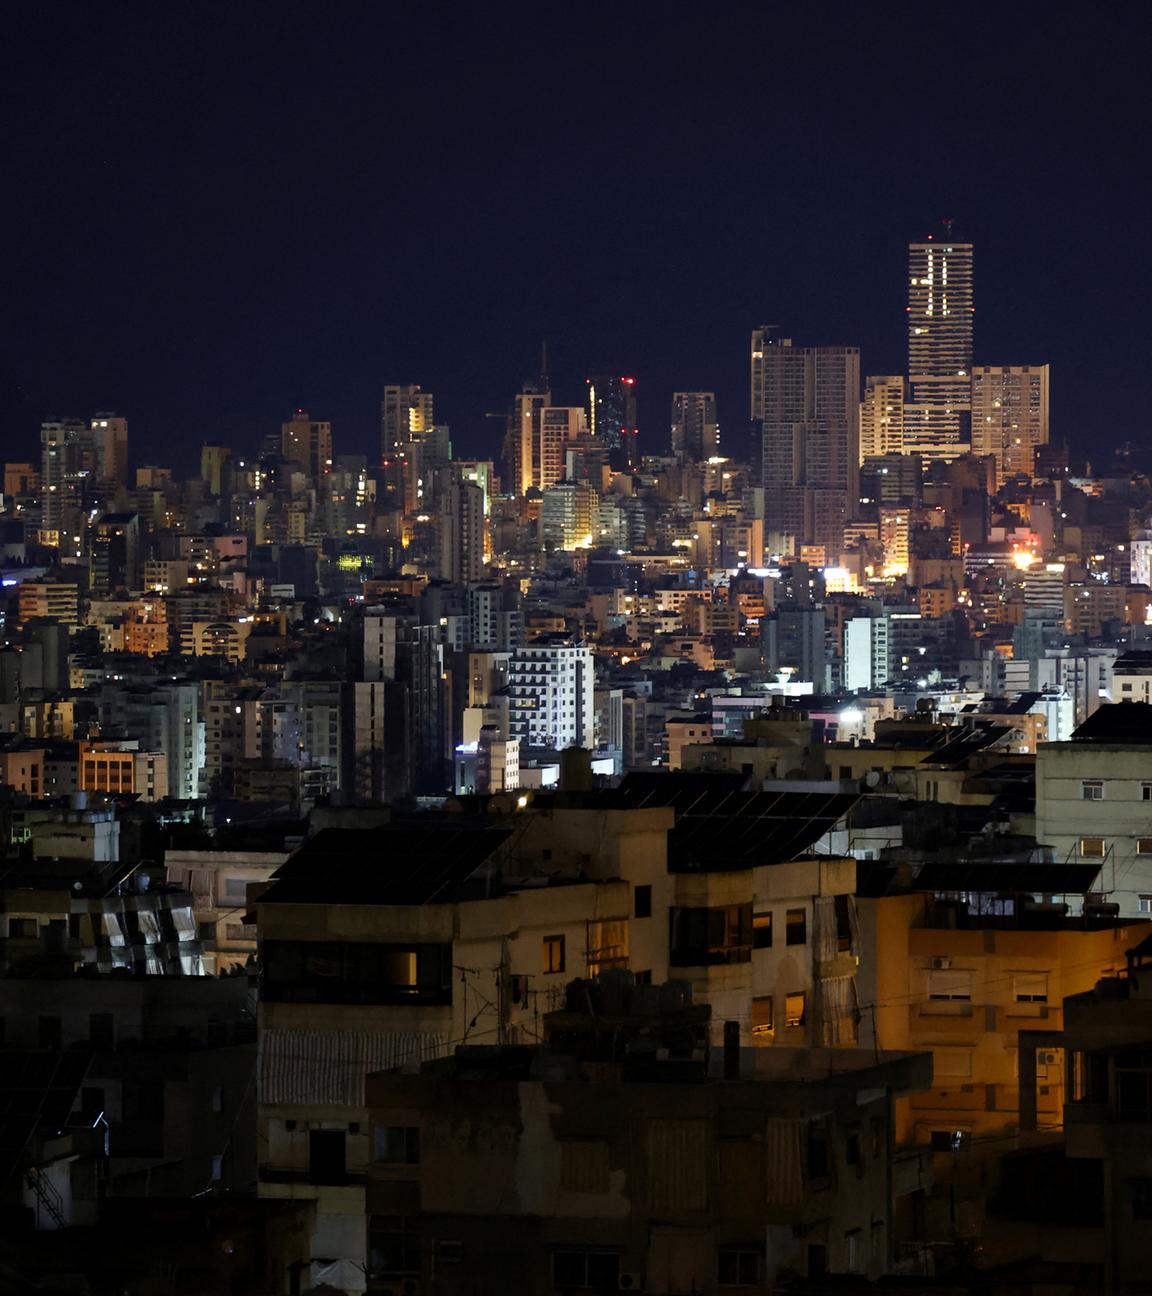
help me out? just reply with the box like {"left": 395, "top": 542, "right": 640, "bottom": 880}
{"left": 904, "top": 226, "right": 976, "bottom": 460}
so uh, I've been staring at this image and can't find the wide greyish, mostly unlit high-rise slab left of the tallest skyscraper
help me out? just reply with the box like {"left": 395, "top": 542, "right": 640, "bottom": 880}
{"left": 752, "top": 328, "right": 860, "bottom": 560}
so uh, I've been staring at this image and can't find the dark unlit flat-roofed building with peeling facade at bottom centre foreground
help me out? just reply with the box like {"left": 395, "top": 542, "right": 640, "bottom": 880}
{"left": 365, "top": 995, "right": 928, "bottom": 1296}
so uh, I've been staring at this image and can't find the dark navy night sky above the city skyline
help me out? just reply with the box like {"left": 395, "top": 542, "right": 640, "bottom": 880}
{"left": 0, "top": 0, "right": 1152, "bottom": 469}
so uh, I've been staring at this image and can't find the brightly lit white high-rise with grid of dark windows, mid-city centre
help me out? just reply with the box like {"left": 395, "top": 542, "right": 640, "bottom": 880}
{"left": 508, "top": 635, "right": 596, "bottom": 752}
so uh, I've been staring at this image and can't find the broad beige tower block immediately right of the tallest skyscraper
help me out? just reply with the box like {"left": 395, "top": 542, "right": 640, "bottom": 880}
{"left": 972, "top": 364, "right": 1048, "bottom": 486}
